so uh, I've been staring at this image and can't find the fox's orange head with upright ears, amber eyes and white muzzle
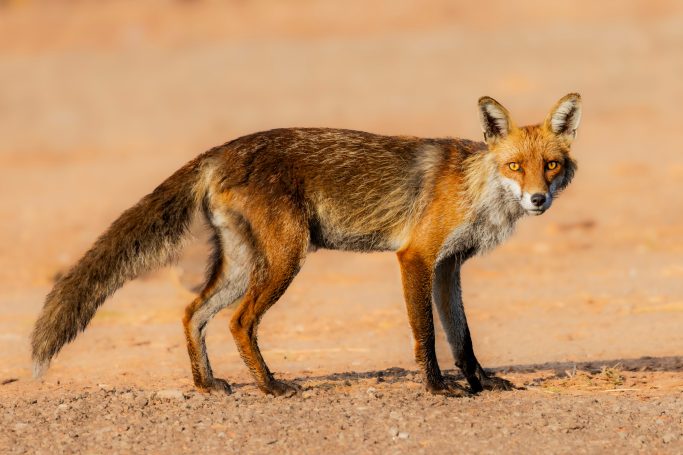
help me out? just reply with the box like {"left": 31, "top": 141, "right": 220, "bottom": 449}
{"left": 479, "top": 93, "right": 581, "bottom": 215}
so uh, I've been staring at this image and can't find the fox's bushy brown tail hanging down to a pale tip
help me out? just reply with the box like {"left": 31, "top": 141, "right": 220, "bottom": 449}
{"left": 31, "top": 156, "right": 211, "bottom": 377}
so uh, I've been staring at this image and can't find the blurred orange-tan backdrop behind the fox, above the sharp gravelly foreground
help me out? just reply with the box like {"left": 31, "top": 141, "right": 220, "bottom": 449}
{"left": 0, "top": 0, "right": 683, "bottom": 383}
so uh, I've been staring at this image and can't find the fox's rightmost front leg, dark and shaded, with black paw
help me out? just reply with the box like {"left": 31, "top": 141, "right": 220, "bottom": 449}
{"left": 432, "top": 256, "right": 514, "bottom": 393}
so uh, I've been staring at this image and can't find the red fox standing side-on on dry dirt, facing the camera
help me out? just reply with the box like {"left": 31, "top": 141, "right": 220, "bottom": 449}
{"left": 32, "top": 93, "right": 581, "bottom": 396}
